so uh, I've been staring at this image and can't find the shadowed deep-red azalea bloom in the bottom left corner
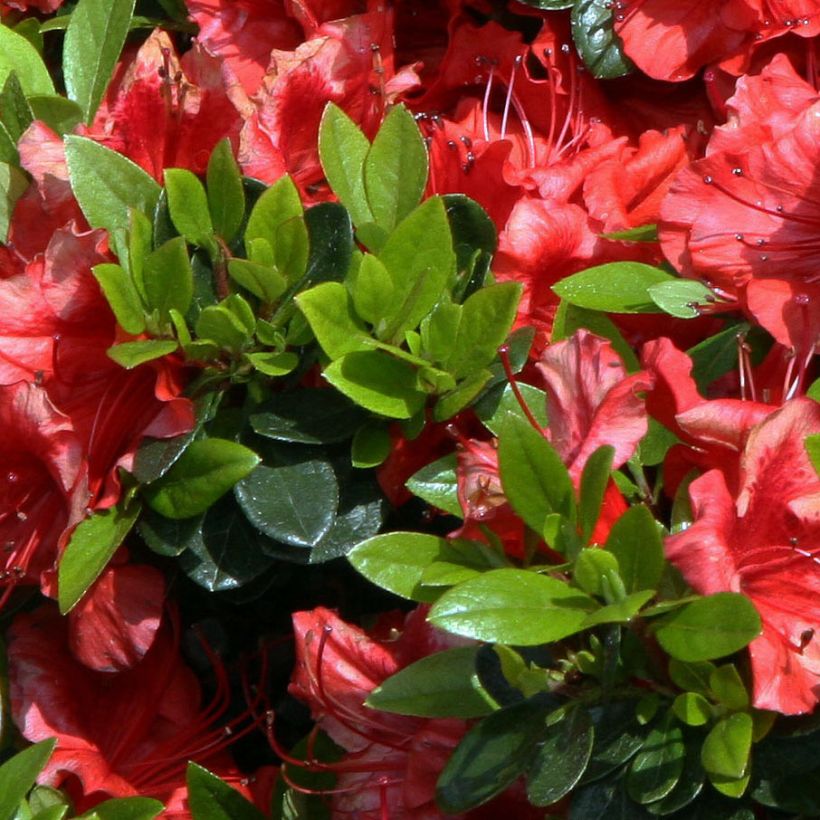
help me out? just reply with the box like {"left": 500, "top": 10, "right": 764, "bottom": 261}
{"left": 8, "top": 604, "right": 270, "bottom": 818}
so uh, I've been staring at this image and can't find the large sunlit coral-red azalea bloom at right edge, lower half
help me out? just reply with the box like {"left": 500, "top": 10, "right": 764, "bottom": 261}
{"left": 666, "top": 398, "right": 820, "bottom": 714}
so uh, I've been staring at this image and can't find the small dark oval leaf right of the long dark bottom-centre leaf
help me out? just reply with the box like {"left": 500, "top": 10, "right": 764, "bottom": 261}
{"left": 527, "top": 706, "right": 595, "bottom": 806}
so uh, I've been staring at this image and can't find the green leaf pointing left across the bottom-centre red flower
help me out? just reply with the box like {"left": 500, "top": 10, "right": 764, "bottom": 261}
{"left": 365, "top": 646, "right": 496, "bottom": 719}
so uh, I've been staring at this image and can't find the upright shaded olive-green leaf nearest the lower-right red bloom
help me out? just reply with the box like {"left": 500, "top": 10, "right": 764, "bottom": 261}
{"left": 605, "top": 505, "right": 664, "bottom": 592}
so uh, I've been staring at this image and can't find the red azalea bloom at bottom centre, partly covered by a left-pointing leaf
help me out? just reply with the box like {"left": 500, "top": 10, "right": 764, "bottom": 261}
{"left": 282, "top": 607, "right": 534, "bottom": 820}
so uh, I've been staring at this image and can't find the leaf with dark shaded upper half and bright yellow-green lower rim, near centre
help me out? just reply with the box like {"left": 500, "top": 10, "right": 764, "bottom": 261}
{"left": 324, "top": 350, "right": 426, "bottom": 419}
